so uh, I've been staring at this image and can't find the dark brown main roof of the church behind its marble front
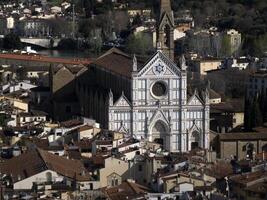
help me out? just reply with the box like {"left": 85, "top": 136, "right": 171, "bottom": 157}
{"left": 92, "top": 48, "right": 142, "bottom": 78}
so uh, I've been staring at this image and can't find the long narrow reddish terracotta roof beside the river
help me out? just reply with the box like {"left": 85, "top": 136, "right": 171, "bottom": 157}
{"left": 0, "top": 54, "right": 91, "bottom": 65}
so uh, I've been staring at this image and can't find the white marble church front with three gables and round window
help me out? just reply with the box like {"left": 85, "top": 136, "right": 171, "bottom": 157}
{"left": 109, "top": 50, "right": 209, "bottom": 152}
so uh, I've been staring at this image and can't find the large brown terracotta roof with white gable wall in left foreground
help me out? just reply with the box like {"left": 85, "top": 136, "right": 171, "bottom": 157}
{"left": 0, "top": 149, "right": 91, "bottom": 182}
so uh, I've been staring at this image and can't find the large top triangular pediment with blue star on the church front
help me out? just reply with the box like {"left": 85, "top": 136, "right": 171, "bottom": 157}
{"left": 138, "top": 51, "right": 181, "bottom": 77}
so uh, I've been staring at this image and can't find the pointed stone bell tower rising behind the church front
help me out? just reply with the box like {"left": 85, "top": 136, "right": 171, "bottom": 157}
{"left": 157, "top": 0, "right": 174, "bottom": 60}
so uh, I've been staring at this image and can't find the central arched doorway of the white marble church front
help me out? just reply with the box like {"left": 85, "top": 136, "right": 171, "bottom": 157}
{"left": 152, "top": 121, "right": 168, "bottom": 148}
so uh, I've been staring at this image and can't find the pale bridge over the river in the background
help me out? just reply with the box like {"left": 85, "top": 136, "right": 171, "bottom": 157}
{"left": 20, "top": 38, "right": 61, "bottom": 49}
